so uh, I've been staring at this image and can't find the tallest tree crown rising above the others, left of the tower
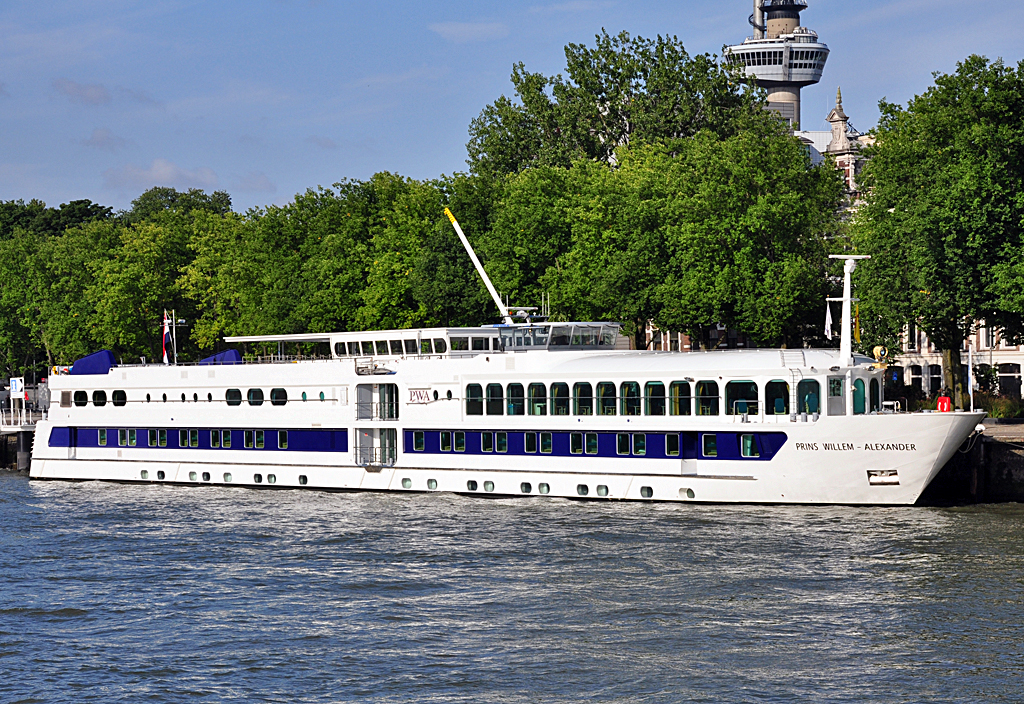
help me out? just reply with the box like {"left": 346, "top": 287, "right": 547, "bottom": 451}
{"left": 467, "top": 31, "right": 771, "bottom": 176}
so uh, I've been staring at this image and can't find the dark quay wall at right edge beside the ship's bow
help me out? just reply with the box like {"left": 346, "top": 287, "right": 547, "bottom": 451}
{"left": 918, "top": 419, "right": 1024, "bottom": 505}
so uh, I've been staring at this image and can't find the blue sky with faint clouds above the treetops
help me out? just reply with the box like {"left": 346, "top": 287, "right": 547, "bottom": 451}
{"left": 0, "top": 0, "right": 1024, "bottom": 211}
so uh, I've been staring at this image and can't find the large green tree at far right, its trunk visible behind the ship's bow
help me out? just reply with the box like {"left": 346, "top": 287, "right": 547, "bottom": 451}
{"left": 853, "top": 55, "right": 1024, "bottom": 407}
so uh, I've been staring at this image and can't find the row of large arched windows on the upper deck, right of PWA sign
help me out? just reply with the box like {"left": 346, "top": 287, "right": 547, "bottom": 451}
{"left": 466, "top": 379, "right": 821, "bottom": 415}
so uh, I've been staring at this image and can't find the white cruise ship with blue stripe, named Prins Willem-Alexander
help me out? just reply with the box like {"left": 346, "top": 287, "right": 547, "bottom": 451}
{"left": 30, "top": 215, "right": 984, "bottom": 504}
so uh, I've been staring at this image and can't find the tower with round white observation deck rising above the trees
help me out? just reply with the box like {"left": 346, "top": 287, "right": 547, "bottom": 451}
{"left": 726, "top": 0, "right": 828, "bottom": 129}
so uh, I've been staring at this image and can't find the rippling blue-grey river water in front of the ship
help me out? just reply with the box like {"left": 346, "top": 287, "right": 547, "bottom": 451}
{"left": 0, "top": 473, "right": 1024, "bottom": 703}
